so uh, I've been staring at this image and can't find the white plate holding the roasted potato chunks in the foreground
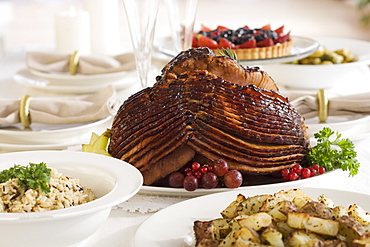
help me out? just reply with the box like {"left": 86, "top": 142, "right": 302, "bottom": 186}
{"left": 134, "top": 187, "right": 370, "bottom": 247}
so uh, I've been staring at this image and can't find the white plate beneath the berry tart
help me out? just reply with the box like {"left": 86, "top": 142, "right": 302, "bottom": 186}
{"left": 158, "top": 36, "right": 319, "bottom": 65}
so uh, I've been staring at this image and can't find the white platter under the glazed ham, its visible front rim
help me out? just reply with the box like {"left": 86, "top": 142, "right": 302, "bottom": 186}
{"left": 139, "top": 169, "right": 343, "bottom": 198}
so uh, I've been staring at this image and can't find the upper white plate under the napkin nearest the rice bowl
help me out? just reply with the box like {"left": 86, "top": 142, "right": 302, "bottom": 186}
{"left": 0, "top": 117, "right": 112, "bottom": 145}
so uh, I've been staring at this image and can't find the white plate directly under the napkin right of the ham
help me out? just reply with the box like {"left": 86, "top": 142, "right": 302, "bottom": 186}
{"left": 305, "top": 114, "right": 370, "bottom": 141}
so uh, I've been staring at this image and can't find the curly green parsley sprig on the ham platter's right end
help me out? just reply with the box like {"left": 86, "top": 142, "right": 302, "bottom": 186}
{"left": 307, "top": 127, "right": 360, "bottom": 176}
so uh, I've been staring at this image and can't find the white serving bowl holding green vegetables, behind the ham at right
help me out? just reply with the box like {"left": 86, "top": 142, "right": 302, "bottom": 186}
{"left": 262, "top": 37, "right": 370, "bottom": 90}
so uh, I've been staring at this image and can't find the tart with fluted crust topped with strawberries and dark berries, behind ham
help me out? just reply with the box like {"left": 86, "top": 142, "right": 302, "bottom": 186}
{"left": 192, "top": 25, "right": 293, "bottom": 60}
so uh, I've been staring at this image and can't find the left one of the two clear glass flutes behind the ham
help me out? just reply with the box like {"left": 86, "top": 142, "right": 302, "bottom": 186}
{"left": 122, "top": 0, "right": 159, "bottom": 88}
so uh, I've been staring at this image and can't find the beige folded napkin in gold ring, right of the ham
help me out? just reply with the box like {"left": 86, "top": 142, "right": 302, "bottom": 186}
{"left": 283, "top": 92, "right": 370, "bottom": 118}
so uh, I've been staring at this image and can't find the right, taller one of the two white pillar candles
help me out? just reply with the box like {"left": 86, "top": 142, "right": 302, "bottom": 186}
{"left": 83, "top": 0, "right": 120, "bottom": 55}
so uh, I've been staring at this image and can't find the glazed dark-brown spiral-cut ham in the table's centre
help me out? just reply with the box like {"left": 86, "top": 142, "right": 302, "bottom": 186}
{"left": 109, "top": 47, "right": 309, "bottom": 185}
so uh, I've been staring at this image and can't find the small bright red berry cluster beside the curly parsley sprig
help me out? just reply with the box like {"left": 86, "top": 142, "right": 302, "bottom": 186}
{"left": 280, "top": 164, "right": 325, "bottom": 181}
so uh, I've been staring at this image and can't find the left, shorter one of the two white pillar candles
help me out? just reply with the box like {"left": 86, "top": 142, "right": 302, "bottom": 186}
{"left": 55, "top": 7, "right": 91, "bottom": 54}
